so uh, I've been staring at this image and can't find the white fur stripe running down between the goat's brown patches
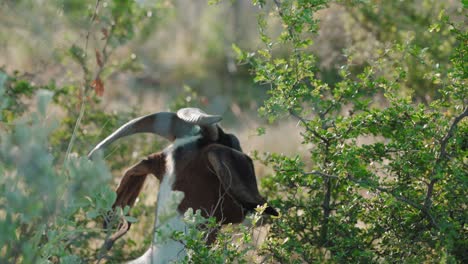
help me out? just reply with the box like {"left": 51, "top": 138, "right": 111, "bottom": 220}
{"left": 129, "top": 135, "right": 201, "bottom": 264}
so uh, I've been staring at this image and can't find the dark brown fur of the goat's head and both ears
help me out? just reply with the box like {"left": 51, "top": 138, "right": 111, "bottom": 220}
{"left": 114, "top": 144, "right": 277, "bottom": 243}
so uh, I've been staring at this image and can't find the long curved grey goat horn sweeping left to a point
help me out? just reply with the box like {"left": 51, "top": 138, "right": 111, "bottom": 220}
{"left": 88, "top": 112, "right": 198, "bottom": 158}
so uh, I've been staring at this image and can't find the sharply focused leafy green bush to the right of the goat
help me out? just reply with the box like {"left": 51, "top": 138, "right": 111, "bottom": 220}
{"left": 235, "top": 0, "right": 468, "bottom": 263}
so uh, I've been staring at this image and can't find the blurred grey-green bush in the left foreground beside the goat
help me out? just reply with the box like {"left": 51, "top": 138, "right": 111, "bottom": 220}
{"left": 0, "top": 81, "right": 115, "bottom": 263}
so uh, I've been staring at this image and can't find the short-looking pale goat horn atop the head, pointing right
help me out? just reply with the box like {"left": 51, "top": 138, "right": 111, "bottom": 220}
{"left": 177, "top": 108, "right": 222, "bottom": 140}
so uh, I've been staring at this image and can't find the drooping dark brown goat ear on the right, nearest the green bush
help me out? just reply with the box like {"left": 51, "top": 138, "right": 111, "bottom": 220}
{"left": 207, "top": 145, "right": 265, "bottom": 209}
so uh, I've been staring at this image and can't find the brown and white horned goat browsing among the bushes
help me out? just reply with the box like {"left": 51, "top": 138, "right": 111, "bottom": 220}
{"left": 89, "top": 108, "right": 278, "bottom": 263}
